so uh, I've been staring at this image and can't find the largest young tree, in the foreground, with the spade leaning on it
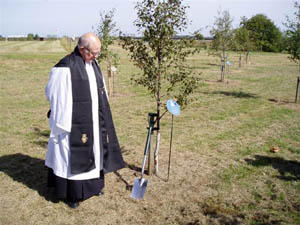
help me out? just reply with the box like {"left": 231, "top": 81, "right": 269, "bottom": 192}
{"left": 122, "top": 0, "right": 198, "bottom": 173}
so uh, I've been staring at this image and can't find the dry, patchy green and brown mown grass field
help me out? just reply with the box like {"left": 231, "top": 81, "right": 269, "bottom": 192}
{"left": 0, "top": 41, "right": 300, "bottom": 225}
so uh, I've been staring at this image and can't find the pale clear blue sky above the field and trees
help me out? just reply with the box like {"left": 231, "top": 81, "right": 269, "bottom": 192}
{"left": 0, "top": 0, "right": 295, "bottom": 37}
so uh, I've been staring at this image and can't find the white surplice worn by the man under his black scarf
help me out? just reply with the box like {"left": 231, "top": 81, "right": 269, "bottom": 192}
{"left": 45, "top": 63, "right": 106, "bottom": 180}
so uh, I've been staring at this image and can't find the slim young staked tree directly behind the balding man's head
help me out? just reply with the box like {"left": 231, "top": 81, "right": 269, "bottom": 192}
{"left": 97, "top": 9, "right": 119, "bottom": 96}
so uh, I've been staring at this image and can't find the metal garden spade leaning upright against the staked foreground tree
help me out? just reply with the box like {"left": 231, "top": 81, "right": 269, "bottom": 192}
{"left": 130, "top": 113, "right": 155, "bottom": 199}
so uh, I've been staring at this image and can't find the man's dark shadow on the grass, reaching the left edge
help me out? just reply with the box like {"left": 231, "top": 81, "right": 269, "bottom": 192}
{"left": 0, "top": 153, "right": 58, "bottom": 203}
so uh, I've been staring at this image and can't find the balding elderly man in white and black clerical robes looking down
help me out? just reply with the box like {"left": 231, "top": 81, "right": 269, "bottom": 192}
{"left": 45, "top": 33, "right": 125, "bottom": 208}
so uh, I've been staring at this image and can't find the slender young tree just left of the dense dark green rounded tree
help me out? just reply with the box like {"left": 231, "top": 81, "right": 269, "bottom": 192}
{"left": 210, "top": 11, "right": 233, "bottom": 82}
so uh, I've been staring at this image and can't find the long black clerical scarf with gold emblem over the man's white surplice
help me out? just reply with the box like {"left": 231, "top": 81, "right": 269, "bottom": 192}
{"left": 55, "top": 47, "right": 125, "bottom": 174}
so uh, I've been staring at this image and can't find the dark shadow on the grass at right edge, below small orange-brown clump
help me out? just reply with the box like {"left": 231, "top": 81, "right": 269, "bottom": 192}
{"left": 245, "top": 155, "right": 300, "bottom": 181}
